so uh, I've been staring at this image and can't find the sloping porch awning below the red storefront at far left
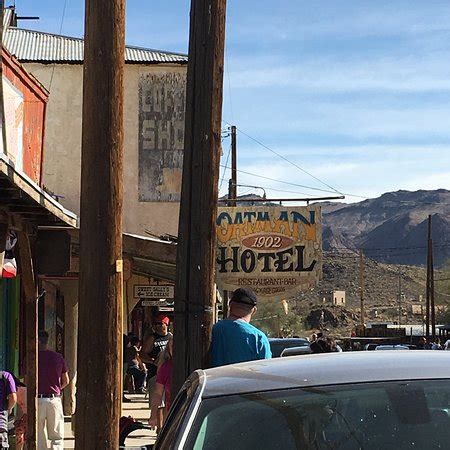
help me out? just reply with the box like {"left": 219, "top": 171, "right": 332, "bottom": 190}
{"left": 0, "top": 153, "right": 78, "bottom": 227}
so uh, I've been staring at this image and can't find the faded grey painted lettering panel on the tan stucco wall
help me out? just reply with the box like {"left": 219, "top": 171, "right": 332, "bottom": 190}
{"left": 139, "top": 73, "right": 186, "bottom": 202}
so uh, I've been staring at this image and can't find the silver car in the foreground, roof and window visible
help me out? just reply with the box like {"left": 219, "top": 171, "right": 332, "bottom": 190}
{"left": 153, "top": 351, "right": 450, "bottom": 450}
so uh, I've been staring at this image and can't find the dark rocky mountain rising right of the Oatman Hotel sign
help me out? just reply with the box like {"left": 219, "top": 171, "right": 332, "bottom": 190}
{"left": 323, "top": 189, "right": 450, "bottom": 267}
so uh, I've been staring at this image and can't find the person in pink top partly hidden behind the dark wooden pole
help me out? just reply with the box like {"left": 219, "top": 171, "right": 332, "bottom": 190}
{"left": 148, "top": 337, "right": 173, "bottom": 432}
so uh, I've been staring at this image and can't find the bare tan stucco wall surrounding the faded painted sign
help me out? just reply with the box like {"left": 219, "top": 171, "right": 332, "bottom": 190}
{"left": 25, "top": 63, "right": 186, "bottom": 239}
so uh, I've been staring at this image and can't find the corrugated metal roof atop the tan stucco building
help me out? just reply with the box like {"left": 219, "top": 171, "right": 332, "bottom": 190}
{"left": 3, "top": 27, "right": 187, "bottom": 64}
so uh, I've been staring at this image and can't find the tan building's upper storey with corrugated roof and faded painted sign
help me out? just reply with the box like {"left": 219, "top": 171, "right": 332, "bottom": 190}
{"left": 4, "top": 10, "right": 187, "bottom": 236}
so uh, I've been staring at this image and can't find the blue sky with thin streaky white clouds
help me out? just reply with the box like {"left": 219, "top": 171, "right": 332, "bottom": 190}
{"left": 9, "top": 0, "right": 450, "bottom": 202}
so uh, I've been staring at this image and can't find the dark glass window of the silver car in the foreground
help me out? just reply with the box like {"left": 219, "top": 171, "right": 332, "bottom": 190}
{"left": 185, "top": 380, "right": 450, "bottom": 450}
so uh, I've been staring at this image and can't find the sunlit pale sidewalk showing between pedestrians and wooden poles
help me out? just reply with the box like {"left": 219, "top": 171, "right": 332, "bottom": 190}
{"left": 64, "top": 394, "right": 156, "bottom": 448}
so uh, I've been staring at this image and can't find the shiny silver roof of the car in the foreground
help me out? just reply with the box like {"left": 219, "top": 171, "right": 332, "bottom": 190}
{"left": 200, "top": 350, "right": 450, "bottom": 397}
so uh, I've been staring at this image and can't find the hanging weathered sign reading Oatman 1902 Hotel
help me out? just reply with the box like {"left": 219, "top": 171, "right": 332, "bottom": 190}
{"left": 216, "top": 206, "right": 322, "bottom": 299}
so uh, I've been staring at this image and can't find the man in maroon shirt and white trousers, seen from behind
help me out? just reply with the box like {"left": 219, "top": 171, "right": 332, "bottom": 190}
{"left": 37, "top": 331, "right": 69, "bottom": 450}
